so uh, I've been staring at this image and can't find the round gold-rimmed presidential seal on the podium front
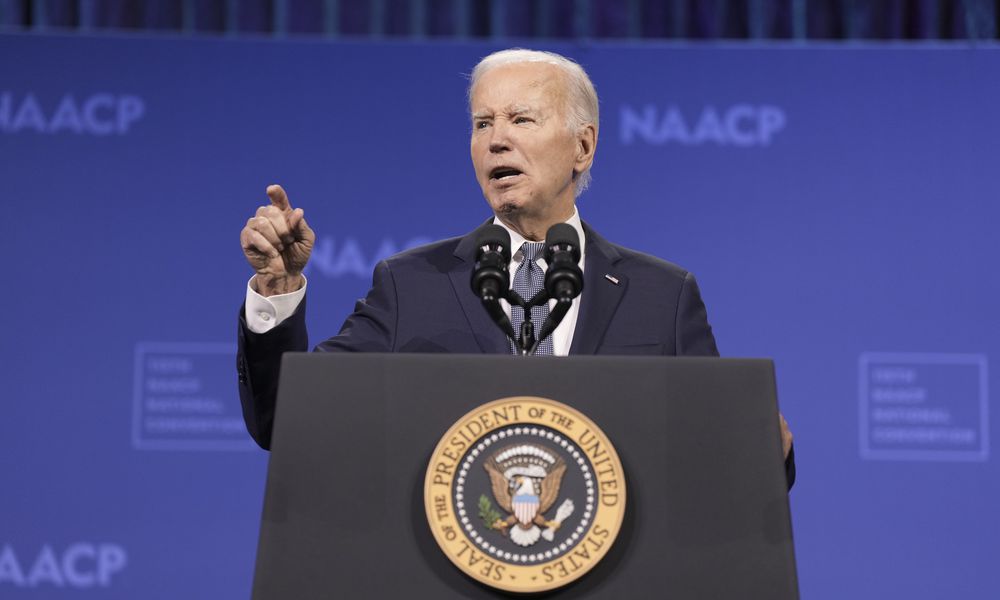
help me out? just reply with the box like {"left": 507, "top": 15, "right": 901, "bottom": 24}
{"left": 424, "top": 397, "right": 625, "bottom": 592}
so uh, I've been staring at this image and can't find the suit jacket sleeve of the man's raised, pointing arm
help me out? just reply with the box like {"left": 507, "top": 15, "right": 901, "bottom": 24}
{"left": 236, "top": 261, "right": 397, "bottom": 450}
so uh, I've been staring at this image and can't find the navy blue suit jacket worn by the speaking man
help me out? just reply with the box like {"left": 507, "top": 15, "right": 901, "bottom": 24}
{"left": 237, "top": 223, "right": 796, "bottom": 486}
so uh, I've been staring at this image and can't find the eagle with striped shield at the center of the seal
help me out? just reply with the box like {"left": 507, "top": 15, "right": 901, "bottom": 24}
{"left": 483, "top": 444, "right": 573, "bottom": 546}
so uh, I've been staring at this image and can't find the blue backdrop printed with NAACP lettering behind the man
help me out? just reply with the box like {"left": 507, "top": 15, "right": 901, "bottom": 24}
{"left": 0, "top": 35, "right": 1000, "bottom": 599}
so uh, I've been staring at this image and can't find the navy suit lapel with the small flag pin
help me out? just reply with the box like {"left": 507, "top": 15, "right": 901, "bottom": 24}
{"left": 569, "top": 223, "right": 628, "bottom": 354}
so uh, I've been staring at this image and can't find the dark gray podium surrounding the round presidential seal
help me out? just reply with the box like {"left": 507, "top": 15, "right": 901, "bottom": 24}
{"left": 253, "top": 353, "right": 798, "bottom": 600}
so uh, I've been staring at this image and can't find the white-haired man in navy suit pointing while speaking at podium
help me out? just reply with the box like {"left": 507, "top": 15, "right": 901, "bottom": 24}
{"left": 238, "top": 50, "right": 794, "bottom": 484}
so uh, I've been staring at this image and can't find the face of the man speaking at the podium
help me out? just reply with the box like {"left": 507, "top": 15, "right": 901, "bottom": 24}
{"left": 471, "top": 63, "right": 593, "bottom": 229}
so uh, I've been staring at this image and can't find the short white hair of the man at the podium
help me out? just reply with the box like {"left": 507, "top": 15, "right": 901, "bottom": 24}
{"left": 468, "top": 48, "right": 600, "bottom": 196}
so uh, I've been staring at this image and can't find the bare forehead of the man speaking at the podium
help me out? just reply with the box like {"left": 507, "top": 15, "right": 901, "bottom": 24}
{"left": 471, "top": 63, "right": 566, "bottom": 112}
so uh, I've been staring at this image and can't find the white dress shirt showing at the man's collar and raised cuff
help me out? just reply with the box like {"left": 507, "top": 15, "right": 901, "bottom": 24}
{"left": 244, "top": 207, "right": 587, "bottom": 356}
